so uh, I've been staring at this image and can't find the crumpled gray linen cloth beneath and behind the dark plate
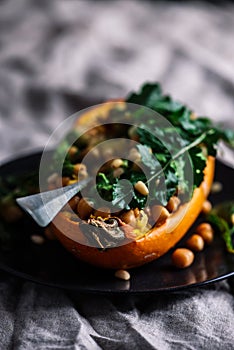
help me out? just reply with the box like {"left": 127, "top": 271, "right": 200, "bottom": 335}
{"left": 0, "top": 0, "right": 234, "bottom": 350}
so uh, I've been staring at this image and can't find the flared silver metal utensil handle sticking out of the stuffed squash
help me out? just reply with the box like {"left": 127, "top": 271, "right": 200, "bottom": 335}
{"left": 16, "top": 178, "right": 92, "bottom": 227}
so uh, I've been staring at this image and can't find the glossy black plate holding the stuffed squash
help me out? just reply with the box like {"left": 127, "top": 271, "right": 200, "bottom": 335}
{"left": 0, "top": 153, "right": 234, "bottom": 293}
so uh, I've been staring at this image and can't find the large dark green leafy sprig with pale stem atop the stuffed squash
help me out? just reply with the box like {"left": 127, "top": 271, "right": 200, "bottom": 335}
{"left": 95, "top": 84, "right": 234, "bottom": 212}
